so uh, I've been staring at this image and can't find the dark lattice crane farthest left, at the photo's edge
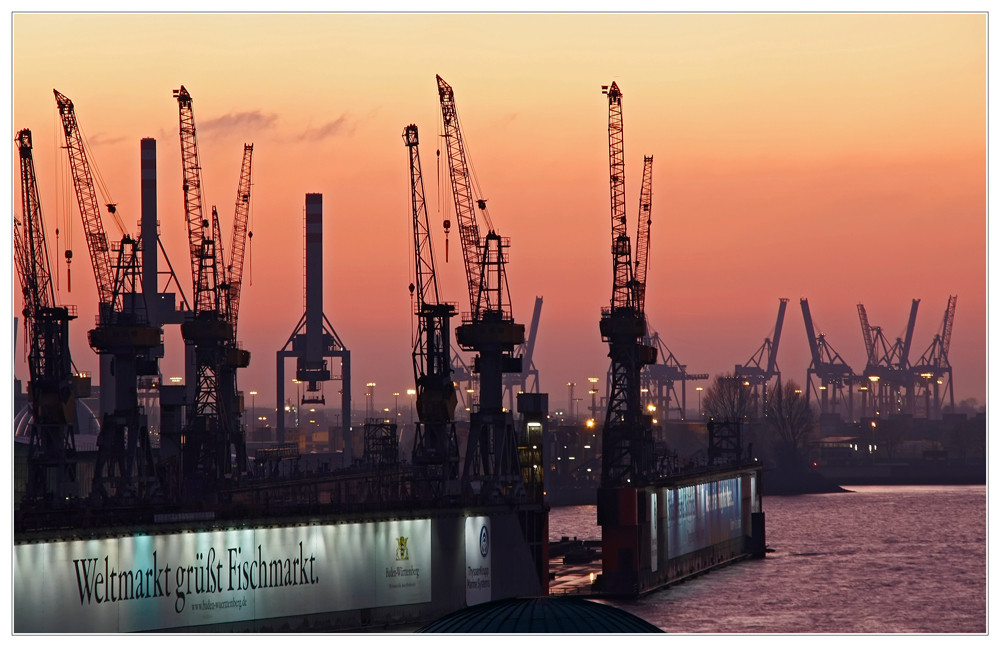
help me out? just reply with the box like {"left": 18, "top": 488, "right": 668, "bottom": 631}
{"left": 14, "top": 129, "right": 89, "bottom": 506}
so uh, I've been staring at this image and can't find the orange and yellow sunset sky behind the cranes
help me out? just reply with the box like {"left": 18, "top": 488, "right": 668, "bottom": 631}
{"left": 8, "top": 13, "right": 987, "bottom": 418}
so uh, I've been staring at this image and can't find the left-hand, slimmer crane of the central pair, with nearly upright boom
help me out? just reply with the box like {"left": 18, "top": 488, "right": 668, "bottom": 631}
{"left": 403, "top": 124, "right": 458, "bottom": 495}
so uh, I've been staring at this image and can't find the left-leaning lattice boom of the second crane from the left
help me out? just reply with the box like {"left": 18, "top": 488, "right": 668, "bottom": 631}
{"left": 52, "top": 89, "right": 114, "bottom": 304}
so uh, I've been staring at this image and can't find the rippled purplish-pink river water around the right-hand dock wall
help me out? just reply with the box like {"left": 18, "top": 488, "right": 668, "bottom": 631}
{"left": 549, "top": 486, "right": 987, "bottom": 634}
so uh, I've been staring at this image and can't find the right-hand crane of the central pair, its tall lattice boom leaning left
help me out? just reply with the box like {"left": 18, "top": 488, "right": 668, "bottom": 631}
{"left": 437, "top": 76, "right": 524, "bottom": 500}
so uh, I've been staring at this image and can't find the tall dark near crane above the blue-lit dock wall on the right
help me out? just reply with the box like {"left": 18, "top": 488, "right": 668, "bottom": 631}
{"left": 600, "top": 83, "right": 656, "bottom": 488}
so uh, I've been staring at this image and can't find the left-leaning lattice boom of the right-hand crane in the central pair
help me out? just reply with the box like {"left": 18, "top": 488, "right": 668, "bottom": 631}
{"left": 436, "top": 76, "right": 489, "bottom": 319}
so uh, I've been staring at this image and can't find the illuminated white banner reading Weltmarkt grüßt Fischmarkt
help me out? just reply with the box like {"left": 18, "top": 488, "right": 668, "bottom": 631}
{"left": 14, "top": 519, "right": 432, "bottom": 633}
